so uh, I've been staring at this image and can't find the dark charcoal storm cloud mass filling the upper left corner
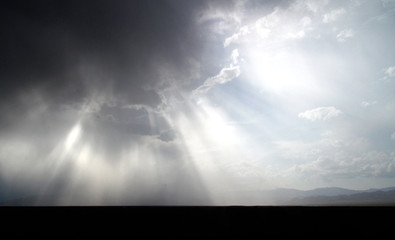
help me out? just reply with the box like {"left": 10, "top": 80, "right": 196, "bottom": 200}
{"left": 0, "top": 1, "right": 207, "bottom": 109}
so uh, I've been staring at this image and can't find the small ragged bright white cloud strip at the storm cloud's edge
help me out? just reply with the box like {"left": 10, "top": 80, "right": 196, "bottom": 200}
{"left": 192, "top": 66, "right": 241, "bottom": 95}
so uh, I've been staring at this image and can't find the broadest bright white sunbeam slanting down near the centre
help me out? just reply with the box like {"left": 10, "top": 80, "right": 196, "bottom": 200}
{"left": 164, "top": 97, "right": 270, "bottom": 204}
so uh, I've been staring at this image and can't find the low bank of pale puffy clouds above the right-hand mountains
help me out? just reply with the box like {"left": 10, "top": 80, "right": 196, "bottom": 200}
{"left": 281, "top": 136, "right": 395, "bottom": 181}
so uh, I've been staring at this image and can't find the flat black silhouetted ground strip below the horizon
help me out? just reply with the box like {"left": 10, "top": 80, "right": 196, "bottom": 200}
{"left": 0, "top": 206, "right": 395, "bottom": 239}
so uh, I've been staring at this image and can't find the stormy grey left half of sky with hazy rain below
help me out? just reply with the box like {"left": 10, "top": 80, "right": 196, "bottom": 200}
{"left": 0, "top": 0, "right": 218, "bottom": 203}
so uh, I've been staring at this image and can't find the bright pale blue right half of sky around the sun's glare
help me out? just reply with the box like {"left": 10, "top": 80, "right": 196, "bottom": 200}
{"left": 187, "top": 1, "right": 395, "bottom": 189}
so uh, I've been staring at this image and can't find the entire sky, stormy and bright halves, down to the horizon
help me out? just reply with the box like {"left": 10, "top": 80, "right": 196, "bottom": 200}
{"left": 0, "top": 0, "right": 395, "bottom": 205}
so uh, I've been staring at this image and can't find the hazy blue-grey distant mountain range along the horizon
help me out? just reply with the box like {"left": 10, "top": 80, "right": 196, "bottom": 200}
{"left": 0, "top": 187, "right": 395, "bottom": 206}
